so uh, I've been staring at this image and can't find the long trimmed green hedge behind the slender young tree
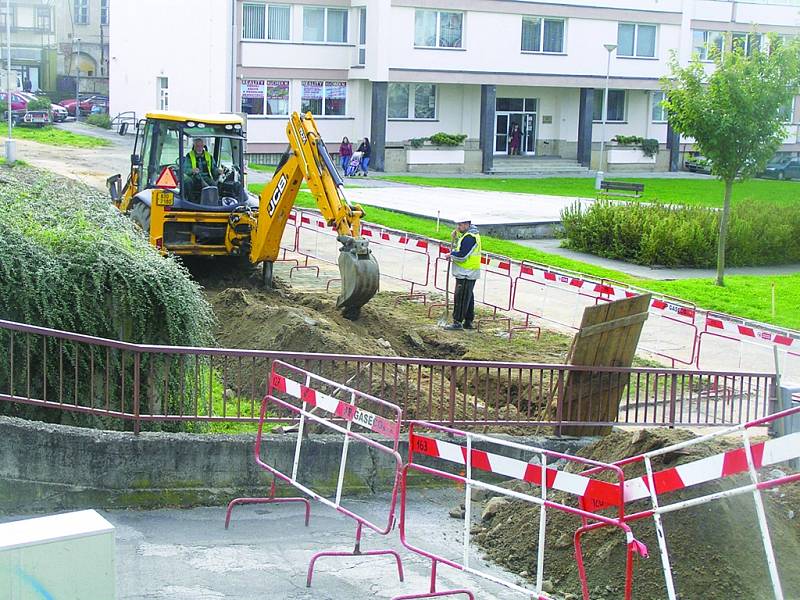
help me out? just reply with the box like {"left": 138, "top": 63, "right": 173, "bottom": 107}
{"left": 561, "top": 200, "right": 800, "bottom": 268}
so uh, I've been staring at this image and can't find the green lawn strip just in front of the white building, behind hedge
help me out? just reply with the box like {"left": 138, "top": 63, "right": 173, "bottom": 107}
{"left": 383, "top": 175, "right": 800, "bottom": 207}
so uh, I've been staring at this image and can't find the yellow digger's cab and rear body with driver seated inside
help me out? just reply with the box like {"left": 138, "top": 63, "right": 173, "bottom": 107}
{"left": 108, "top": 112, "right": 259, "bottom": 255}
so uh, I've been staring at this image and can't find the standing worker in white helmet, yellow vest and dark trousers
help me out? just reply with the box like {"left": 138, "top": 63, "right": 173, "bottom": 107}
{"left": 445, "top": 219, "right": 481, "bottom": 330}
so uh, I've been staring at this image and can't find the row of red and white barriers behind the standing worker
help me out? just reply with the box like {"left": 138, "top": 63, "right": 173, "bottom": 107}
{"left": 281, "top": 211, "right": 800, "bottom": 381}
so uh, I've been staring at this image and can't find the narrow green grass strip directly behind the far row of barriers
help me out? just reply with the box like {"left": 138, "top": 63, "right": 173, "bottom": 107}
{"left": 250, "top": 182, "right": 800, "bottom": 329}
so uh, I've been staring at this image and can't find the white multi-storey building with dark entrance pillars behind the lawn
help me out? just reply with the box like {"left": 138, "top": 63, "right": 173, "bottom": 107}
{"left": 111, "top": 0, "right": 800, "bottom": 171}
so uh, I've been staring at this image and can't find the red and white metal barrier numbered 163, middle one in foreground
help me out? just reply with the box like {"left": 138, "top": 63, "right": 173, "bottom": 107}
{"left": 394, "top": 421, "right": 647, "bottom": 600}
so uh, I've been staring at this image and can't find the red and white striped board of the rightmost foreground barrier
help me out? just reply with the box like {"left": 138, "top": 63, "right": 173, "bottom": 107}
{"left": 585, "top": 432, "right": 800, "bottom": 510}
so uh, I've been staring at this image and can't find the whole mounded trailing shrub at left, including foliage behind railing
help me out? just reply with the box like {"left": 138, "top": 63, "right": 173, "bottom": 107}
{"left": 0, "top": 168, "right": 214, "bottom": 427}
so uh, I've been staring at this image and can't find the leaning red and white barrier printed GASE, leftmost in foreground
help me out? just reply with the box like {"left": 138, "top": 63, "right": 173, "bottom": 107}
{"left": 227, "top": 361, "right": 404, "bottom": 587}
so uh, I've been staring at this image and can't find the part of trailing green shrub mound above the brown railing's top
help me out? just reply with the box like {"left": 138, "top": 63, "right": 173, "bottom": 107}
{"left": 0, "top": 167, "right": 213, "bottom": 345}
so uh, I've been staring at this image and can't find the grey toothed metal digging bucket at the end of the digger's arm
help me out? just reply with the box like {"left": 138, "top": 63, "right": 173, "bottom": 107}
{"left": 336, "top": 235, "right": 381, "bottom": 319}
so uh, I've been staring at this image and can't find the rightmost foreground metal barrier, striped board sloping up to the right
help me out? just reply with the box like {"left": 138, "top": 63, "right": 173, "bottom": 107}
{"left": 576, "top": 406, "right": 800, "bottom": 600}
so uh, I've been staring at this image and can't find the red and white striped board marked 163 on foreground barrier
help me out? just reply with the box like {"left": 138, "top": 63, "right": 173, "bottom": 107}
{"left": 411, "top": 434, "right": 621, "bottom": 504}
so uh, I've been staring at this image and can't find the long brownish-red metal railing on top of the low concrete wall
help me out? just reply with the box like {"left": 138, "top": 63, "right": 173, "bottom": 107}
{"left": 0, "top": 321, "right": 775, "bottom": 431}
